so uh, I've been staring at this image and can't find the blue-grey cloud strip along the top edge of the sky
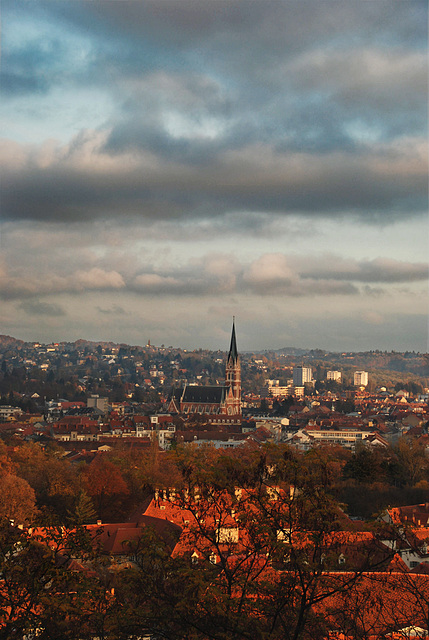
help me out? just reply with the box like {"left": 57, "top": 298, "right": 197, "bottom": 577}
{"left": 61, "top": 0, "right": 427, "bottom": 54}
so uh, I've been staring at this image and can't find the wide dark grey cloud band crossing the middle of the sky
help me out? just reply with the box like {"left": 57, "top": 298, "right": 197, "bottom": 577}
{"left": 2, "top": 131, "right": 427, "bottom": 222}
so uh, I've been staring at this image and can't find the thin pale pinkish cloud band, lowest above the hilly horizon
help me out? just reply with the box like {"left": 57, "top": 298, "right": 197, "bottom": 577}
{"left": 0, "top": 248, "right": 429, "bottom": 299}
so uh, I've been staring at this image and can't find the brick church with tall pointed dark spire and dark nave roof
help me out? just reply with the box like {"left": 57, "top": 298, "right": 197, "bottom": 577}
{"left": 168, "top": 322, "right": 241, "bottom": 425}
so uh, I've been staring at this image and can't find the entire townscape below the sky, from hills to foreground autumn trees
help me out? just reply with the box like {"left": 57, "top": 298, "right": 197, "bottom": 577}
{"left": 0, "top": 324, "right": 429, "bottom": 640}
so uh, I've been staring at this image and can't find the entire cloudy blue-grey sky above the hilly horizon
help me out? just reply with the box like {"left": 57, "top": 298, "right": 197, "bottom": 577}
{"left": 0, "top": 0, "right": 429, "bottom": 351}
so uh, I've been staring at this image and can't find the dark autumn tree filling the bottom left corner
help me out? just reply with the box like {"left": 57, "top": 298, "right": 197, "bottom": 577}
{"left": 0, "top": 520, "right": 118, "bottom": 640}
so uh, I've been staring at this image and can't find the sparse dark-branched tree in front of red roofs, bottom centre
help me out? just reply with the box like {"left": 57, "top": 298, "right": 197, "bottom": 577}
{"left": 114, "top": 448, "right": 394, "bottom": 640}
